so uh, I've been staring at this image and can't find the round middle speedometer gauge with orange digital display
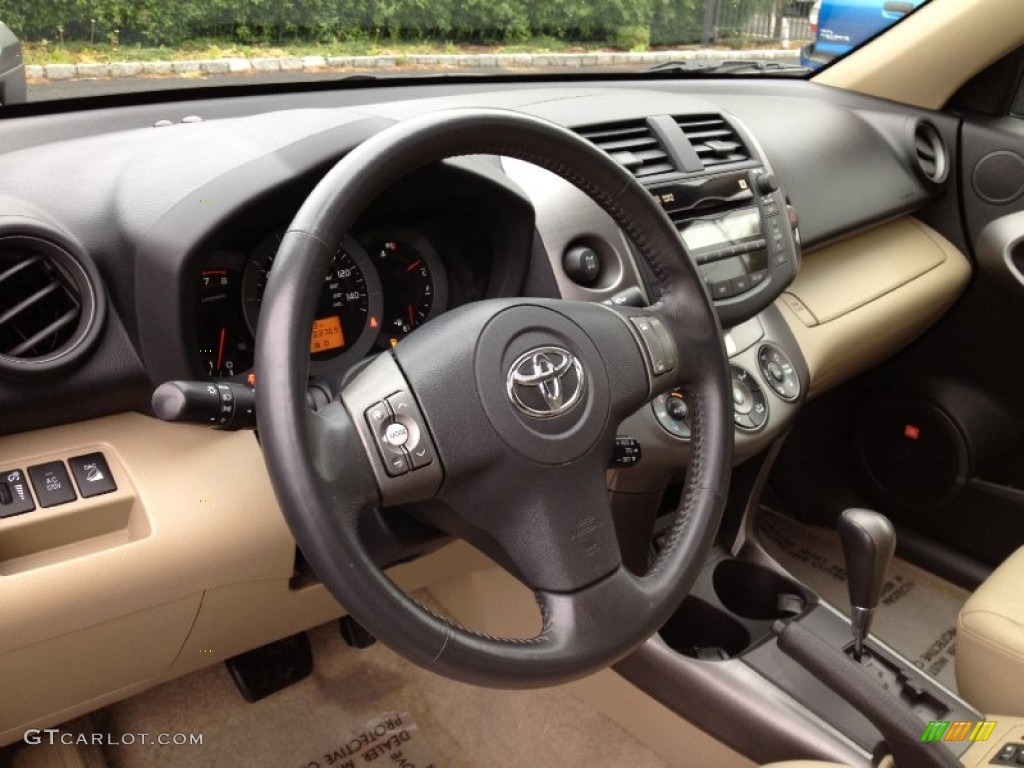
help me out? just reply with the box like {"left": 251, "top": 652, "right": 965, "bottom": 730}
{"left": 242, "top": 230, "right": 381, "bottom": 364}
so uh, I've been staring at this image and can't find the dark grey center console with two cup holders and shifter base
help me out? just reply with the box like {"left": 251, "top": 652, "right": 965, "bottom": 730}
{"left": 616, "top": 507, "right": 987, "bottom": 768}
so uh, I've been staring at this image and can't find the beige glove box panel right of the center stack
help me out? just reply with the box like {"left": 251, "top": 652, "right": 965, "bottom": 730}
{"left": 776, "top": 217, "right": 971, "bottom": 396}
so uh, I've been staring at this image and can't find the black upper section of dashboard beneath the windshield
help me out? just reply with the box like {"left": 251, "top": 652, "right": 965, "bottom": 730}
{"left": 0, "top": 81, "right": 944, "bottom": 432}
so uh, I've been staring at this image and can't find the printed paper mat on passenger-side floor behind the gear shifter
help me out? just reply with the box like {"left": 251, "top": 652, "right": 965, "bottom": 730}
{"left": 757, "top": 509, "right": 970, "bottom": 691}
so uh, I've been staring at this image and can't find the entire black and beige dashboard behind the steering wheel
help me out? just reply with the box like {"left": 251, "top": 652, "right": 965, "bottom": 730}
{"left": 0, "top": 80, "right": 970, "bottom": 743}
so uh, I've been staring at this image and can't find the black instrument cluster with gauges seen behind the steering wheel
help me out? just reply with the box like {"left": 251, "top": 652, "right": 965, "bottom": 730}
{"left": 192, "top": 174, "right": 494, "bottom": 379}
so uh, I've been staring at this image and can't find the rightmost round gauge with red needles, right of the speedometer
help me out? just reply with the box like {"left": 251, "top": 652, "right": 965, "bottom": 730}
{"left": 361, "top": 226, "right": 447, "bottom": 347}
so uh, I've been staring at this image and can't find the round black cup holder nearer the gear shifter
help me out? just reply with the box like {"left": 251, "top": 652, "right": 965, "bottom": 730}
{"left": 712, "top": 559, "right": 807, "bottom": 622}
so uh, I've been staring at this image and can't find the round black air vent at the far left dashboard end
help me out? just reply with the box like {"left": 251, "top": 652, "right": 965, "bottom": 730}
{"left": 0, "top": 234, "right": 103, "bottom": 376}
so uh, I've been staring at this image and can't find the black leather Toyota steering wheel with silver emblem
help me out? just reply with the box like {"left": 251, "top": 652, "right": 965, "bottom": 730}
{"left": 256, "top": 109, "right": 732, "bottom": 688}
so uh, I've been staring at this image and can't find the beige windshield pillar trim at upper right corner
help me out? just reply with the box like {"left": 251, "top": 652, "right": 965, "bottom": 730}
{"left": 814, "top": 0, "right": 1024, "bottom": 110}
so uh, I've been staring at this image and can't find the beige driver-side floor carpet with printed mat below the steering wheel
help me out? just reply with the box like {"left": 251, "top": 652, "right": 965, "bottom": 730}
{"left": 66, "top": 624, "right": 668, "bottom": 768}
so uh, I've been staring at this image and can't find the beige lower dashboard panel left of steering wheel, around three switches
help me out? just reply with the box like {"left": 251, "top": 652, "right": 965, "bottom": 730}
{"left": 0, "top": 414, "right": 488, "bottom": 745}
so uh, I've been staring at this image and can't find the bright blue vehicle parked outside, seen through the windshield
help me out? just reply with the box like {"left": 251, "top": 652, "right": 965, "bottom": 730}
{"left": 800, "top": 0, "right": 925, "bottom": 69}
